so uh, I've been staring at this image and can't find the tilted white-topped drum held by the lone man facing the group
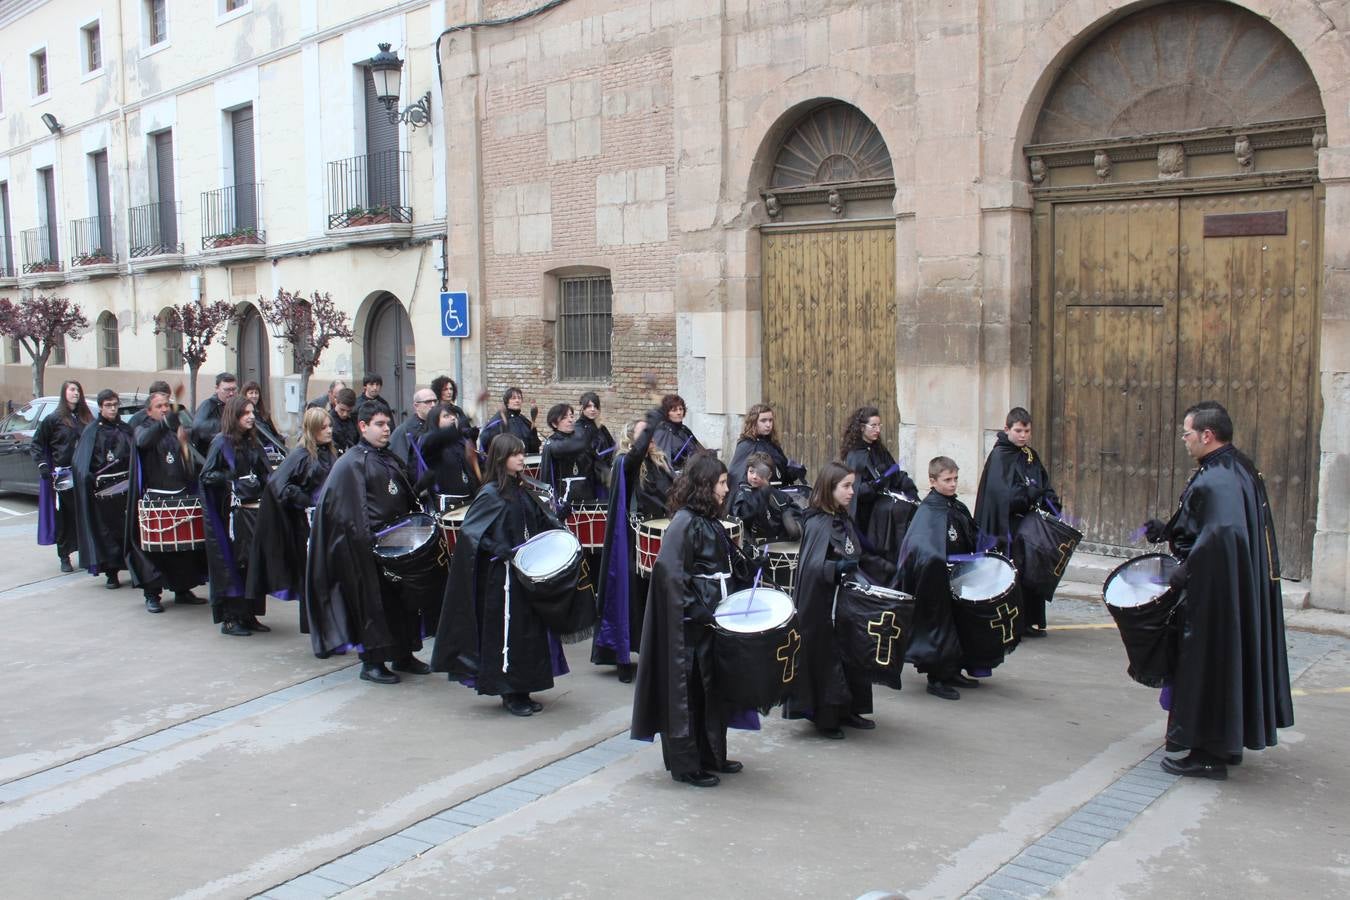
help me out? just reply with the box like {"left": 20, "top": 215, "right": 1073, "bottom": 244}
{"left": 1102, "top": 553, "right": 1181, "bottom": 688}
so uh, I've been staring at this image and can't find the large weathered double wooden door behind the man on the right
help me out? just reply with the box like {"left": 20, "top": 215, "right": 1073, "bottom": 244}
{"left": 1041, "top": 189, "right": 1320, "bottom": 578}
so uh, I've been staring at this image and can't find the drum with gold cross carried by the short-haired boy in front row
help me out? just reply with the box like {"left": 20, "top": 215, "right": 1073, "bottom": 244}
{"left": 950, "top": 553, "right": 1022, "bottom": 669}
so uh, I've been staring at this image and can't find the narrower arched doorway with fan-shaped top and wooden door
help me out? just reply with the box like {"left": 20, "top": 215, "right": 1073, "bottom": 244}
{"left": 760, "top": 101, "right": 898, "bottom": 472}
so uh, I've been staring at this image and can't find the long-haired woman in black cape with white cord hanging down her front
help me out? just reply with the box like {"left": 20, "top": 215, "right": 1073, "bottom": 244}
{"left": 431, "top": 434, "right": 568, "bottom": 716}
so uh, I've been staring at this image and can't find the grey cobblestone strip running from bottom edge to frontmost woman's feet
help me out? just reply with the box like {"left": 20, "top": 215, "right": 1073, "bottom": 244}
{"left": 255, "top": 733, "right": 651, "bottom": 900}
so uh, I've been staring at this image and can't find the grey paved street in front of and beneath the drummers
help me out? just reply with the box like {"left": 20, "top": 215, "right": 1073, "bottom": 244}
{"left": 0, "top": 497, "right": 1350, "bottom": 899}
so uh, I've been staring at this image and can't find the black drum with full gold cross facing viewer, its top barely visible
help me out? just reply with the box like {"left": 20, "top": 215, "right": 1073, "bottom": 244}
{"left": 833, "top": 580, "right": 914, "bottom": 691}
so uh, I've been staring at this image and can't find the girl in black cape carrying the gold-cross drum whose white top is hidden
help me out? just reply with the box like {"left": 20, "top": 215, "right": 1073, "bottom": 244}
{"left": 783, "top": 461, "right": 876, "bottom": 741}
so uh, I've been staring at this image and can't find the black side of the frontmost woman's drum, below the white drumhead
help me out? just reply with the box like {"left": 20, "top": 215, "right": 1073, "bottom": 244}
{"left": 713, "top": 615, "right": 801, "bottom": 710}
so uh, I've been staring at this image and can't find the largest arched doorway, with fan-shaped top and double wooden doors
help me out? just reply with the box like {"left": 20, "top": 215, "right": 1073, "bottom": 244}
{"left": 1026, "top": 3, "right": 1324, "bottom": 578}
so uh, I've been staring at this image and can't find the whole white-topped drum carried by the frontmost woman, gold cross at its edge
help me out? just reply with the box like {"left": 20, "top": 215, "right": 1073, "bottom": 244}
{"left": 713, "top": 587, "right": 802, "bottom": 710}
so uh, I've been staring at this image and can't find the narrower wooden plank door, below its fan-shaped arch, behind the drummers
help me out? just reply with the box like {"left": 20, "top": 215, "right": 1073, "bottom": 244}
{"left": 761, "top": 227, "right": 899, "bottom": 478}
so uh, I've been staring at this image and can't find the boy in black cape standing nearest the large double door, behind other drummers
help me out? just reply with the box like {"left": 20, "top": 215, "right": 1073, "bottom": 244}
{"left": 975, "top": 406, "right": 1060, "bottom": 637}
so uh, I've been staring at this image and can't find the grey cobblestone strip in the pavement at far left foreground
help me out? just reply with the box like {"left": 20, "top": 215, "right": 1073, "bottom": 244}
{"left": 0, "top": 664, "right": 358, "bottom": 806}
